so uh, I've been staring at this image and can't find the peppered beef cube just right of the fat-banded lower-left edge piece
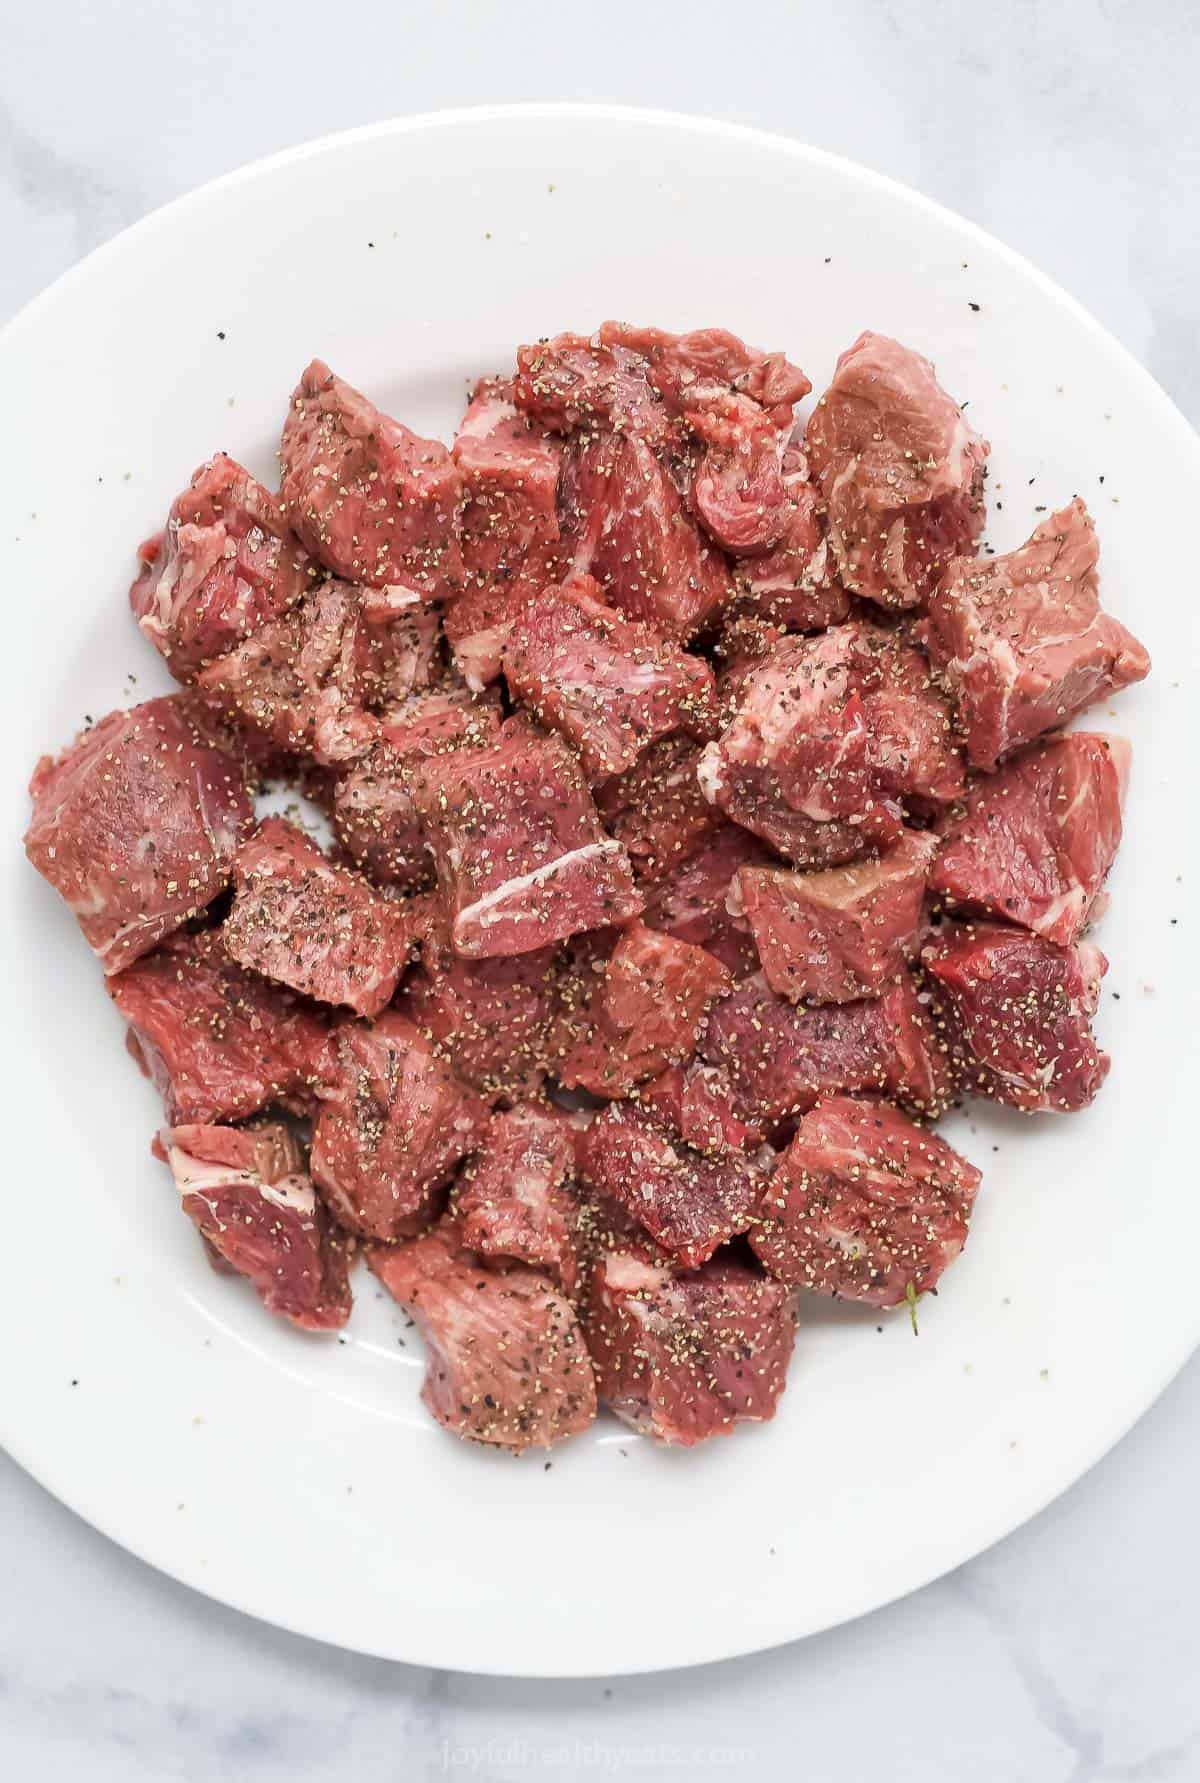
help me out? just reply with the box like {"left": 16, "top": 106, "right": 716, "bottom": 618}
{"left": 312, "top": 1009, "right": 487, "bottom": 1239}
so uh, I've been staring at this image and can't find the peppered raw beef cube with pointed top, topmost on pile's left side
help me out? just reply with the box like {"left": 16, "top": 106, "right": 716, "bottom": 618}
{"left": 280, "top": 358, "right": 462, "bottom": 601}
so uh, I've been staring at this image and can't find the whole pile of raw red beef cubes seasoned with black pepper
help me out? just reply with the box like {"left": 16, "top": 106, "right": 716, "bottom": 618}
{"left": 27, "top": 323, "right": 1148, "bottom": 1450}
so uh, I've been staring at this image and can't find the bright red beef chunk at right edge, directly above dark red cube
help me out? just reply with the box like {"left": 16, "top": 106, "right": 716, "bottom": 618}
{"left": 929, "top": 731, "right": 1130, "bottom": 947}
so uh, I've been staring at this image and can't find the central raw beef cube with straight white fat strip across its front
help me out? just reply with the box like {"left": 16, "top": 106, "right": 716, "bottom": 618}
{"left": 404, "top": 719, "right": 642, "bottom": 959}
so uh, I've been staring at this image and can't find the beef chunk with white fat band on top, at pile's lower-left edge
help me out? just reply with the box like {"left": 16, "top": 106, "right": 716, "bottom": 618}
{"left": 160, "top": 1125, "right": 351, "bottom": 1332}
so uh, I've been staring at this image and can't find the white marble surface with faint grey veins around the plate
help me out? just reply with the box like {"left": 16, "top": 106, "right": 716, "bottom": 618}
{"left": 0, "top": 0, "right": 1200, "bottom": 1783}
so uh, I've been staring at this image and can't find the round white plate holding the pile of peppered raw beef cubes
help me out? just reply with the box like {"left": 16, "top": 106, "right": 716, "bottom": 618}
{"left": 0, "top": 107, "right": 1200, "bottom": 1674}
